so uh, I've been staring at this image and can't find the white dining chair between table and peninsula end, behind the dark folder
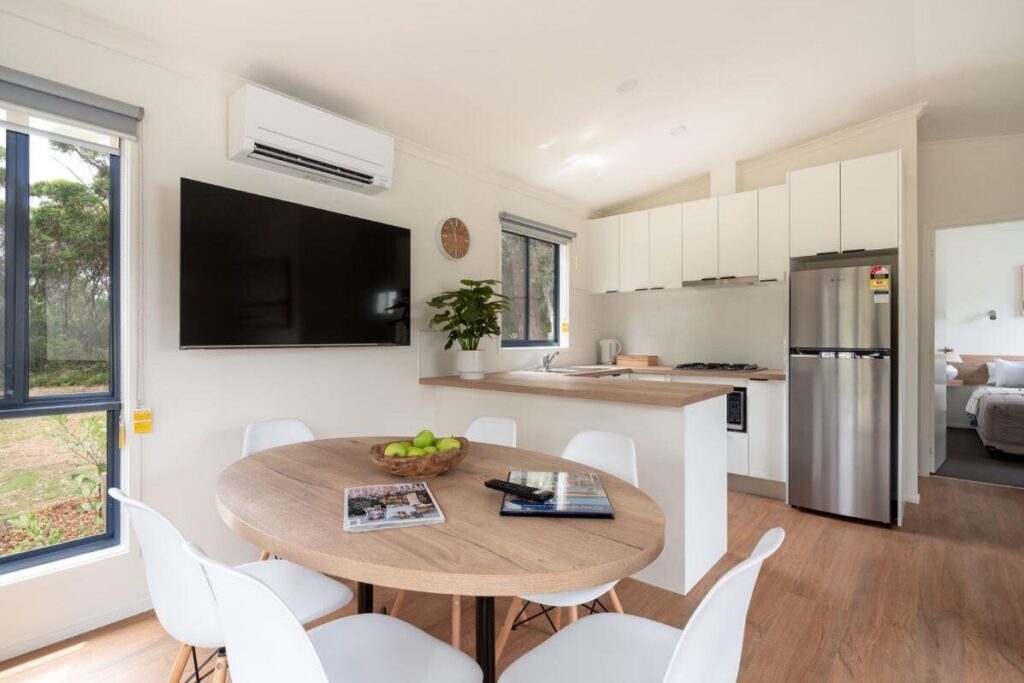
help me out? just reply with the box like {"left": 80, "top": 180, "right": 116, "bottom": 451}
{"left": 495, "top": 431, "right": 639, "bottom": 658}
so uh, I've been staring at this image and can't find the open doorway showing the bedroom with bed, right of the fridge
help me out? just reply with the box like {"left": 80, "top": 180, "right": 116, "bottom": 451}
{"left": 932, "top": 221, "right": 1024, "bottom": 487}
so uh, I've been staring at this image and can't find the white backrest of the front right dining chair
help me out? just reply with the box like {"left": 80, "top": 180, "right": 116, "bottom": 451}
{"left": 665, "top": 526, "right": 785, "bottom": 683}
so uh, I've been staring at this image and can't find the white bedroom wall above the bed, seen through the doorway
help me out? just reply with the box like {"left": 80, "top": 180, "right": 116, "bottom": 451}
{"left": 936, "top": 221, "right": 1024, "bottom": 355}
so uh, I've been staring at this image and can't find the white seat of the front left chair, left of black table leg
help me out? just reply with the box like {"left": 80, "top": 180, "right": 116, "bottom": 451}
{"left": 308, "top": 614, "right": 483, "bottom": 683}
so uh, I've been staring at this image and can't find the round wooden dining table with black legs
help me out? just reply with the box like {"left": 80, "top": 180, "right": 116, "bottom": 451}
{"left": 217, "top": 436, "right": 665, "bottom": 683}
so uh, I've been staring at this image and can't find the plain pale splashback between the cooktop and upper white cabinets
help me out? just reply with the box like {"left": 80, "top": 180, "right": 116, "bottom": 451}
{"left": 601, "top": 284, "right": 787, "bottom": 369}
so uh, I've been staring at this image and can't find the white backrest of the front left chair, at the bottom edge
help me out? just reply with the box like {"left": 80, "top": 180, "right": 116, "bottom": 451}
{"left": 182, "top": 542, "right": 329, "bottom": 683}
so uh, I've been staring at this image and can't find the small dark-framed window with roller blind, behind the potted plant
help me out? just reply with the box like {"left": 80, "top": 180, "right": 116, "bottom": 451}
{"left": 501, "top": 213, "right": 575, "bottom": 348}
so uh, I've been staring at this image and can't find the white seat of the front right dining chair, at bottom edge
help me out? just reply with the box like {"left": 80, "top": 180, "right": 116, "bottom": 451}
{"left": 500, "top": 613, "right": 682, "bottom": 683}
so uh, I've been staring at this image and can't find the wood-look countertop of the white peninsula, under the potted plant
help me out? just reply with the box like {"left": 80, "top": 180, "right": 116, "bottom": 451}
{"left": 420, "top": 370, "right": 730, "bottom": 408}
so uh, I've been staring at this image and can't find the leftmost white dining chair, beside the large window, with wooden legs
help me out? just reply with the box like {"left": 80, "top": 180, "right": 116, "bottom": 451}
{"left": 109, "top": 488, "right": 352, "bottom": 683}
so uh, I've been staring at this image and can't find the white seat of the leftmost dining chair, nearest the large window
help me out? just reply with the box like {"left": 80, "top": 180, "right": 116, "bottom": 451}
{"left": 236, "top": 560, "right": 352, "bottom": 624}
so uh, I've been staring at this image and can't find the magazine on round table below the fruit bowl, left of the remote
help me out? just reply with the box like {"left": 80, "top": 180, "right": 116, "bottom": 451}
{"left": 345, "top": 481, "right": 444, "bottom": 531}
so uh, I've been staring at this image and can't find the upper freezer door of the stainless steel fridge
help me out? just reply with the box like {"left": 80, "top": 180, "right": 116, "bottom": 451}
{"left": 790, "top": 263, "right": 892, "bottom": 349}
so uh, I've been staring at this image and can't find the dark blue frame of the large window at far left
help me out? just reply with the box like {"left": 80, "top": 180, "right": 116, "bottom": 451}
{"left": 0, "top": 129, "right": 122, "bottom": 574}
